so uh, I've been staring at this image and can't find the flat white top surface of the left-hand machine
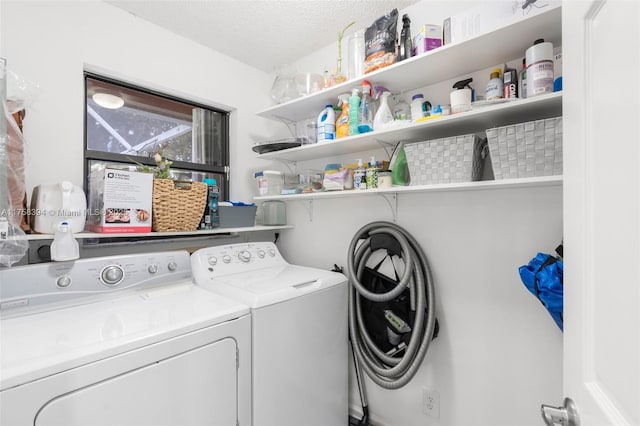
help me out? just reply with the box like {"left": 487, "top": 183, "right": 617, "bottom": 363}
{"left": 0, "top": 281, "right": 249, "bottom": 390}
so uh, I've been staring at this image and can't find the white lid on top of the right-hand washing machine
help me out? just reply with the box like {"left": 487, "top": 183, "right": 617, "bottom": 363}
{"left": 198, "top": 264, "right": 347, "bottom": 308}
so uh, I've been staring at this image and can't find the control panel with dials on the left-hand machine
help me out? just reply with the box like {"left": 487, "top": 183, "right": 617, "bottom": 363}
{"left": 0, "top": 251, "right": 192, "bottom": 317}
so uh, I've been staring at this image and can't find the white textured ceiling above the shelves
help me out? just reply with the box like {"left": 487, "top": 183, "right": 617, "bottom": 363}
{"left": 105, "top": 0, "right": 419, "bottom": 72}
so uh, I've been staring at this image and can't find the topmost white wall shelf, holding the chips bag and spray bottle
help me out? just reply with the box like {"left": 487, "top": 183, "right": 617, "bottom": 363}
{"left": 257, "top": 5, "right": 562, "bottom": 125}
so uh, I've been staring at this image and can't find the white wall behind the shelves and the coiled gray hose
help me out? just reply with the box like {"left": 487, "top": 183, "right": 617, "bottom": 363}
{"left": 280, "top": 0, "right": 562, "bottom": 426}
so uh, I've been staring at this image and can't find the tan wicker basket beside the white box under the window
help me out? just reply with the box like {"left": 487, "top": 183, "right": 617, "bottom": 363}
{"left": 152, "top": 179, "right": 207, "bottom": 232}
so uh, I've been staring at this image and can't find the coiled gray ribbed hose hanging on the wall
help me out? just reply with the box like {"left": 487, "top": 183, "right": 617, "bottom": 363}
{"left": 347, "top": 222, "right": 436, "bottom": 389}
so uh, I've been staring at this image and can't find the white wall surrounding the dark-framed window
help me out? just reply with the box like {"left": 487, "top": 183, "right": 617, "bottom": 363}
{"left": 0, "top": 0, "right": 273, "bottom": 200}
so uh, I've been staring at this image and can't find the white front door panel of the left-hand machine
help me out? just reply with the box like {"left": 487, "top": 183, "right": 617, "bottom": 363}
{"left": 35, "top": 338, "right": 237, "bottom": 426}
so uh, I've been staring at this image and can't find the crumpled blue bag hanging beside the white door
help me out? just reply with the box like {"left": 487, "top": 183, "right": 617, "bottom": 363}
{"left": 519, "top": 253, "right": 564, "bottom": 330}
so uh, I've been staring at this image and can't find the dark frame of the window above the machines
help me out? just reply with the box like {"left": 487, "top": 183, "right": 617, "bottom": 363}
{"left": 83, "top": 70, "right": 231, "bottom": 199}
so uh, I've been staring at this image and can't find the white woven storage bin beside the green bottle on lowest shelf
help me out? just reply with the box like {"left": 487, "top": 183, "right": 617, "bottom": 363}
{"left": 404, "top": 134, "right": 486, "bottom": 185}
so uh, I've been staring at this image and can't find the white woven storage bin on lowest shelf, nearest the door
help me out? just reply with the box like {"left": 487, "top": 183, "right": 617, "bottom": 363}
{"left": 487, "top": 117, "right": 562, "bottom": 179}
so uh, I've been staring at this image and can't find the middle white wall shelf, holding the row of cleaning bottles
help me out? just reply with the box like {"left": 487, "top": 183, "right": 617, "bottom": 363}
{"left": 259, "top": 92, "right": 562, "bottom": 161}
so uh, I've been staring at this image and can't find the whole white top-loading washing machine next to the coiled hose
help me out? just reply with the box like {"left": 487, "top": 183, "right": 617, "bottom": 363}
{"left": 191, "top": 242, "right": 348, "bottom": 426}
